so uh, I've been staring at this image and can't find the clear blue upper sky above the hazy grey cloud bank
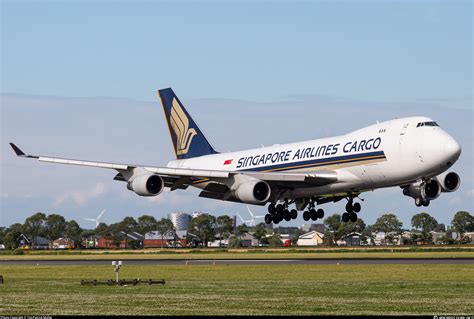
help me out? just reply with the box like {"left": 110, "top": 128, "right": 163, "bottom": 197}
{"left": 2, "top": 1, "right": 472, "bottom": 101}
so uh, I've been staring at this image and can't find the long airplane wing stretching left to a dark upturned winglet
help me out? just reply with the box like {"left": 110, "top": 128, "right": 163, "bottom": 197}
{"left": 10, "top": 143, "right": 338, "bottom": 190}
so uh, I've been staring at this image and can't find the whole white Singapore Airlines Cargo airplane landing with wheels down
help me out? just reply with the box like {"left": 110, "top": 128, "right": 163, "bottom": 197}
{"left": 10, "top": 88, "right": 461, "bottom": 224}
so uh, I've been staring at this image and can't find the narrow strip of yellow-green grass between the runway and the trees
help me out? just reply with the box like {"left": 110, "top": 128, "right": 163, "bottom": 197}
{"left": 0, "top": 245, "right": 474, "bottom": 260}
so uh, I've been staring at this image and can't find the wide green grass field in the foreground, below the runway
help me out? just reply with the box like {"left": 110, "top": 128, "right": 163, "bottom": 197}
{"left": 0, "top": 264, "right": 474, "bottom": 315}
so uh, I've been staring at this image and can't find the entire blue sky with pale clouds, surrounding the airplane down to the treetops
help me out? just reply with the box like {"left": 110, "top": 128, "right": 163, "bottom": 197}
{"left": 0, "top": 1, "right": 474, "bottom": 227}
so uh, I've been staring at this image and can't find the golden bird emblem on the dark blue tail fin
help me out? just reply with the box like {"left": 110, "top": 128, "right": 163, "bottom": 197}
{"left": 170, "top": 98, "right": 197, "bottom": 155}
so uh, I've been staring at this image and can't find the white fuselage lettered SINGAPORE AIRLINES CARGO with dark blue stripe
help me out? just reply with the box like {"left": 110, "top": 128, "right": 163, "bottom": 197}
{"left": 168, "top": 117, "right": 461, "bottom": 198}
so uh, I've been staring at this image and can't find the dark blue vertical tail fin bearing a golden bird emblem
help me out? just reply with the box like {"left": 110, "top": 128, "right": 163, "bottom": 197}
{"left": 158, "top": 88, "right": 217, "bottom": 159}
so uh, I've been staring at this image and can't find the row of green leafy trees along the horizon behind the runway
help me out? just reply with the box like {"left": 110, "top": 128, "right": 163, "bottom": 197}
{"left": 0, "top": 211, "right": 474, "bottom": 249}
